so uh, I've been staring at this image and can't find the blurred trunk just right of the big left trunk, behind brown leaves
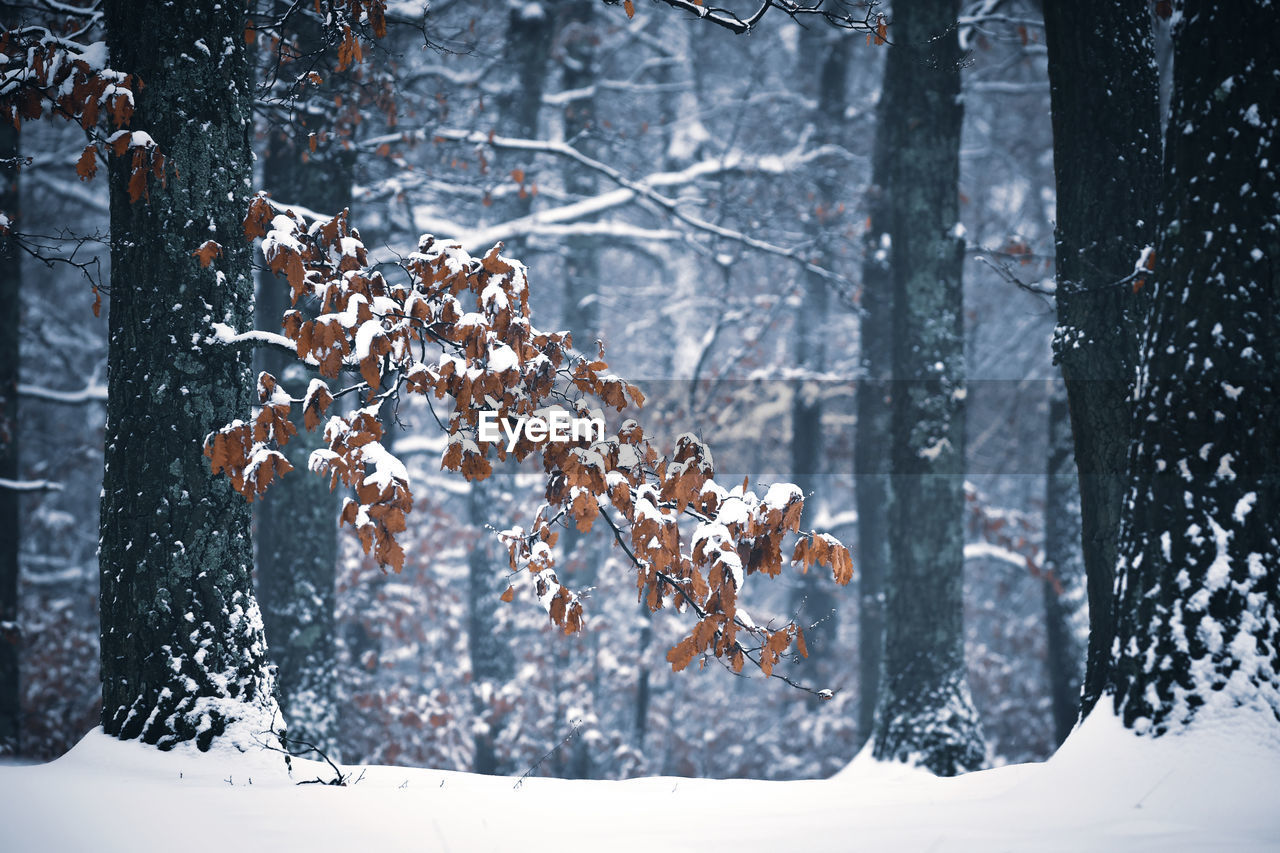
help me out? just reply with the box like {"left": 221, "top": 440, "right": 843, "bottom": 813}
{"left": 255, "top": 81, "right": 355, "bottom": 756}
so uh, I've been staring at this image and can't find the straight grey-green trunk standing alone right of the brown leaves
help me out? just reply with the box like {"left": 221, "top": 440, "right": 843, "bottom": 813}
{"left": 874, "top": 0, "right": 986, "bottom": 776}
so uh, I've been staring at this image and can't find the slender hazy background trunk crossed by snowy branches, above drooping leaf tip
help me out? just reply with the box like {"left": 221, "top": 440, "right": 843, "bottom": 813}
{"left": 791, "top": 31, "right": 850, "bottom": 685}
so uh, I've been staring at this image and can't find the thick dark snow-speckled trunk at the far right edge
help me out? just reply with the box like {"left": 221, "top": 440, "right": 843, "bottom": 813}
{"left": 1108, "top": 3, "right": 1280, "bottom": 735}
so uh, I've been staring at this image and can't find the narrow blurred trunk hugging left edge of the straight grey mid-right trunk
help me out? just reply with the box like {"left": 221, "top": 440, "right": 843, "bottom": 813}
{"left": 854, "top": 54, "right": 893, "bottom": 740}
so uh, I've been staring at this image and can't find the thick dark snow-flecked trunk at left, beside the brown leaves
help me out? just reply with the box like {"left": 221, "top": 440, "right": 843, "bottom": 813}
{"left": 100, "top": 0, "right": 275, "bottom": 749}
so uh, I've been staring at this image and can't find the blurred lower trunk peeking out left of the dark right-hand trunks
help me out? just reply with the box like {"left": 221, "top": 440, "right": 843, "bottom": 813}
{"left": 1043, "top": 387, "right": 1084, "bottom": 743}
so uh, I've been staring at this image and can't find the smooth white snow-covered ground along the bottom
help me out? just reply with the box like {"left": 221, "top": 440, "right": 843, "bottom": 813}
{"left": 0, "top": 713, "right": 1280, "bottom": 853}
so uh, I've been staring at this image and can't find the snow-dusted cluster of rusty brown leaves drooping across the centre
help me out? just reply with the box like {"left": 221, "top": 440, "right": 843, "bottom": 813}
{"left": 205, "top": 195, "right": 852, "bottom": 674}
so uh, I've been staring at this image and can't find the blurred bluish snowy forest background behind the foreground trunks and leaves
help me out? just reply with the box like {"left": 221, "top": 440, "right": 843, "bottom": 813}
{"left": 0, "top": 0, "right": 1087, "bottom": 779}
